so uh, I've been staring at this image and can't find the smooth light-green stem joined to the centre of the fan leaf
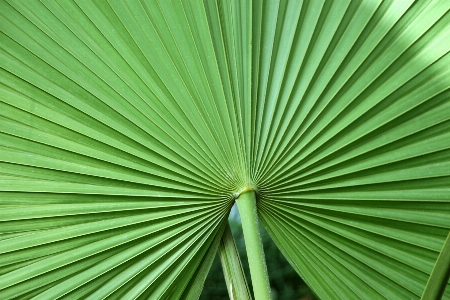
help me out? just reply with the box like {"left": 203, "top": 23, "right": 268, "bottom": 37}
{"left": 236, "top": 189, "right": 270, "bottom": 300}
